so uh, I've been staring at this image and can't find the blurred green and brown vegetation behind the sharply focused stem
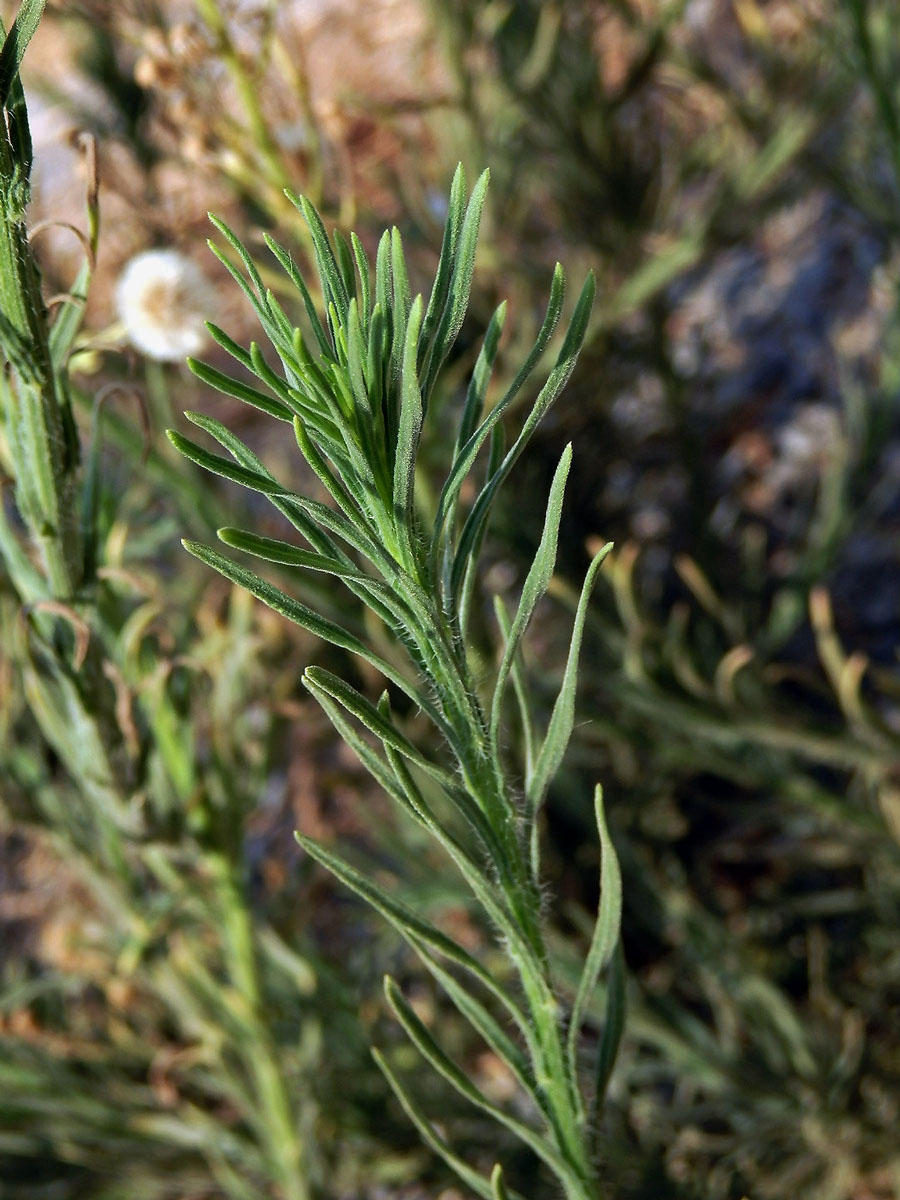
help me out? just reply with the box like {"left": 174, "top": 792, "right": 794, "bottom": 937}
{"left": 0, "top": 0, "right": 900, "bottom": 1200}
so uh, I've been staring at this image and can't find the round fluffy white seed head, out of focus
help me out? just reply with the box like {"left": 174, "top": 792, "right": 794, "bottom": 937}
{"left": 115, "top": 250, "right": 215, "bottom": 362}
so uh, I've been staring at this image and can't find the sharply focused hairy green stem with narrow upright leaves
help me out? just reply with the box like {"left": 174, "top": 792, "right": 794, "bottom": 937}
{"left": 169, "top": 167, "right": 622, "bottom": 1198}
